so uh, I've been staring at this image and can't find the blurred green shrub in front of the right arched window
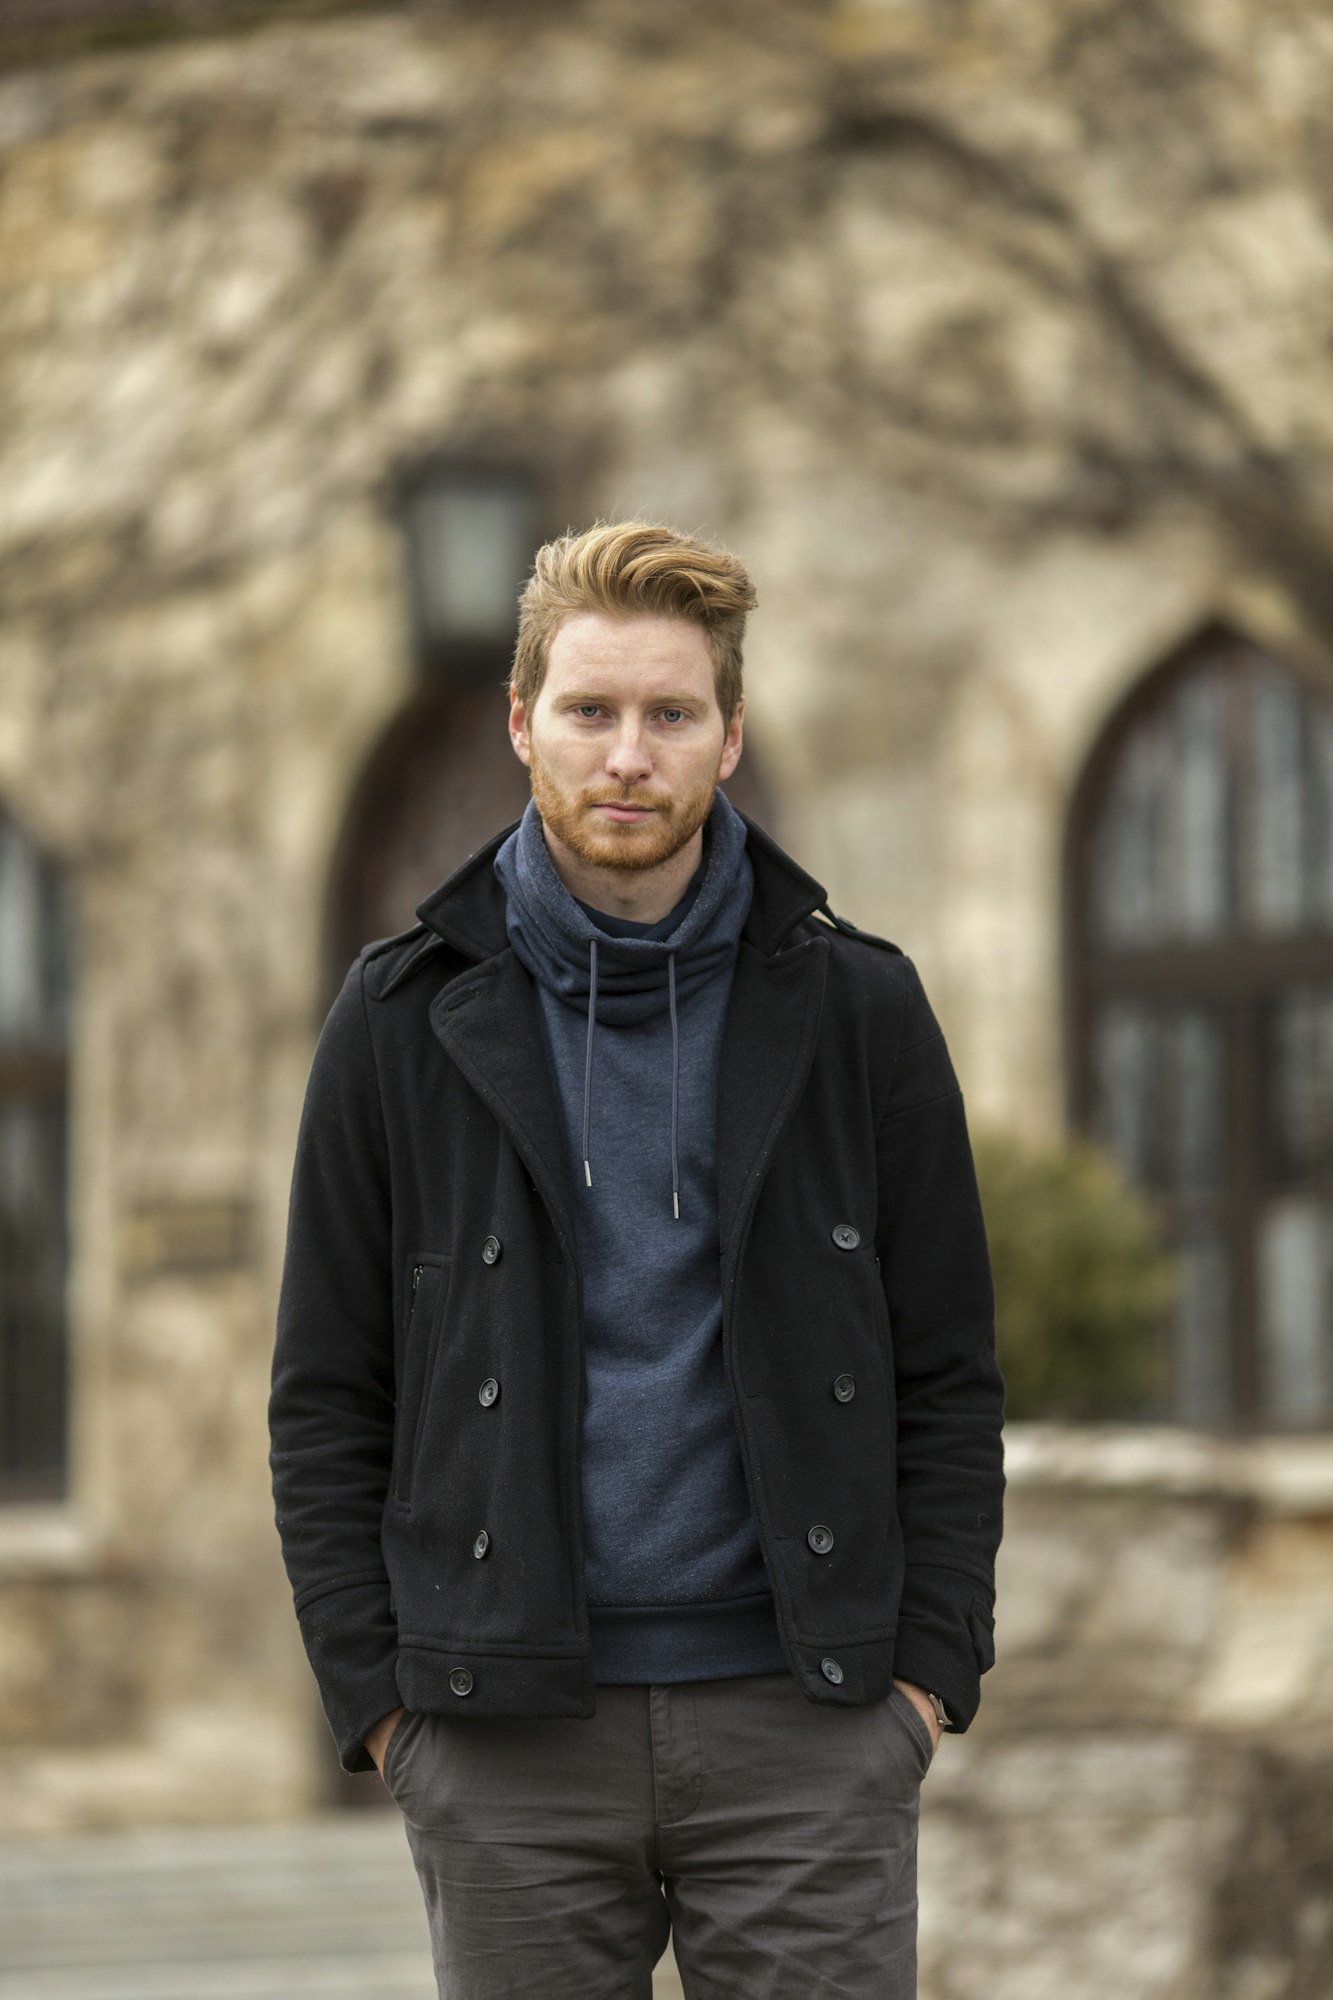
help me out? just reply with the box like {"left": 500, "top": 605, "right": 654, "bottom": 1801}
{"left": 975, "top": 1134, "right": 1177, "bottom": 1422}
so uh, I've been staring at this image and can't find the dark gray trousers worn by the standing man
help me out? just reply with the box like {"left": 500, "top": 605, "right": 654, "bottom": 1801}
{"left": 384, "top": 1674, "right": 931, "bottom": 2000}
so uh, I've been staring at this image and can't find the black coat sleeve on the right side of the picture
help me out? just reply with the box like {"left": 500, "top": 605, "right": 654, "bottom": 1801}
{"left": 877, "top": 958, "right": 1005, "bottom": 1730}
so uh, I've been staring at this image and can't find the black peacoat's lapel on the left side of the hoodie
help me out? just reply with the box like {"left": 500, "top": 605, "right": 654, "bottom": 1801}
{"left": 430, "top": 948, "right": 578, "bottom": 1268}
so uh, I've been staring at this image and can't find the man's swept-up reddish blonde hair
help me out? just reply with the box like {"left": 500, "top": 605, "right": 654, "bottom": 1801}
{"left": 508, "top": 520, "right": 757, "bottom": 722}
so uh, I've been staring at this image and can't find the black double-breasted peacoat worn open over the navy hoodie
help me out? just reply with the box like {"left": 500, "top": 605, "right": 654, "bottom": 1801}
{"left": 270, "top": 808, "right": 1003, "bottom": 1770}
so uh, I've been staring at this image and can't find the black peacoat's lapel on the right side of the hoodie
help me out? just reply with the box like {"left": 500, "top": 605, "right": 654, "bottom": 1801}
{"left": 717, "top": 938, "right": 829, "bottom": 1264}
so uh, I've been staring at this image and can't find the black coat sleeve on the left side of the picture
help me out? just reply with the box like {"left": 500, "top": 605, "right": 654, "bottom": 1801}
{"left": 268, "top": 960, "right": 400, "bottom": 1770}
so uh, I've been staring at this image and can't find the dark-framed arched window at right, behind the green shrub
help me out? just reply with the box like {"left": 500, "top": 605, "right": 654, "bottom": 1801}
{"left": 1065, "top": 628, "right": 1333, "bottom": 1430}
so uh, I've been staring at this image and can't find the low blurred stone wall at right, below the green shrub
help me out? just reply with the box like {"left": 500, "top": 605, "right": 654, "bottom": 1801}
{"left": 921, "top": 1426, "right": 1333, "bottom": 2000}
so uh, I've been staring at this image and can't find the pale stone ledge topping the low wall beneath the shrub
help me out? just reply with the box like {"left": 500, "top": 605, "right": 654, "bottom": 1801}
{"left": 1005, "top": 1424, "right": 1333, "bottom": 1514}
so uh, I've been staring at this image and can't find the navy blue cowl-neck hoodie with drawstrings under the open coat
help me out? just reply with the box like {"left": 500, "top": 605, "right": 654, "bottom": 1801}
{"left": 494, "top": 792, "right": 787, "bottom": 1682}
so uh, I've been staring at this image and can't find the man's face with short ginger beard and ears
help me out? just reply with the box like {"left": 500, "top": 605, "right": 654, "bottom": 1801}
{"left": 508, "top": 612, "right": 745, "bottom": 870}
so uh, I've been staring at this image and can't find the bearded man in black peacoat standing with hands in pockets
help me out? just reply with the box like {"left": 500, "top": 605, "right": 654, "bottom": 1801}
{"left": 272, "top": 522, "right": 1003, "bottom": 2000}
